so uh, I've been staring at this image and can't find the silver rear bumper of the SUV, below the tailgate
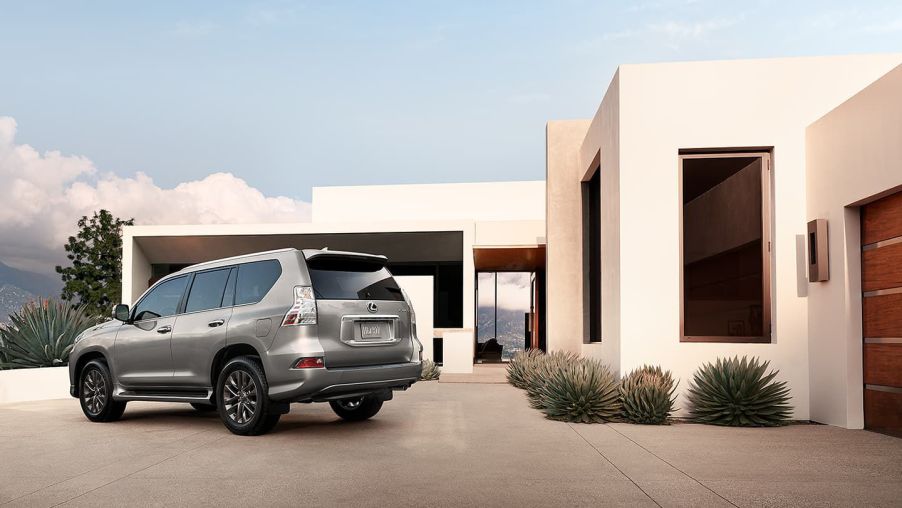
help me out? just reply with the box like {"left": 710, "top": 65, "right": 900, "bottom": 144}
{"left": 269, "top": 362, "right": 423, "bottom": 402}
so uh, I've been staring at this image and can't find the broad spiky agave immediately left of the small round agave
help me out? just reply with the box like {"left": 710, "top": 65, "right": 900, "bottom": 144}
{"left": 538, "top": 358, "right": 620, "bottom": 423}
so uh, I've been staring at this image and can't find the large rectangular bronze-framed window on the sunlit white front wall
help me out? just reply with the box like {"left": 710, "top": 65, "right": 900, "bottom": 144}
{"left": 680, "top": 153, "right": 771, "bottom": 342}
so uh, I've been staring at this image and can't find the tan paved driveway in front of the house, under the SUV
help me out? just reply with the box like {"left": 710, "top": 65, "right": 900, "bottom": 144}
{"left": 0, "top": 382, "right": 902, "bottom": 508}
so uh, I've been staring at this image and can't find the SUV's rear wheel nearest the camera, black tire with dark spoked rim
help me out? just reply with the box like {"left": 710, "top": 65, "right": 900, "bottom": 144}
{"left": 216, "top": 356, "right": 282, "bottom": 436}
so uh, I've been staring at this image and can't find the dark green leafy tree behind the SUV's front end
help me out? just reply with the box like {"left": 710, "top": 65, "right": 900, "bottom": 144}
{"left": 56, "top": 210, "right": 135, "bottom": 316}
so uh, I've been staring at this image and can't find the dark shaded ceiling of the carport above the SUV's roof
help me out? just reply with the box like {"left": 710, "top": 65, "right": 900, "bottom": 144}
{"left": 135, "top": 231, "right": 463, "bottom": 264}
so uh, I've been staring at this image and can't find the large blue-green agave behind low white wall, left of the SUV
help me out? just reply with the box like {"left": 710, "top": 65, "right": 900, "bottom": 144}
{"left": 0, "top": 300, "right": 96, "bottom": 369}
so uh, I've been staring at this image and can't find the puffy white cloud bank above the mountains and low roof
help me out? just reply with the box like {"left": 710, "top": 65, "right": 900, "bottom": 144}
{"left": 0, "top": 117, "right": 310, "bottom": 271}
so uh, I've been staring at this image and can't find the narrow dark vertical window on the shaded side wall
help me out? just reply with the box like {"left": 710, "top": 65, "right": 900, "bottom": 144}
{"left": 582, "top": 167, "right": 601, "bottom": 342}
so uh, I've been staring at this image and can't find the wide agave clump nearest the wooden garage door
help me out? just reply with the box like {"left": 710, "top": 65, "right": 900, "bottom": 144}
{"left": 687, "top": 356, "right": 792, "bottom": 427}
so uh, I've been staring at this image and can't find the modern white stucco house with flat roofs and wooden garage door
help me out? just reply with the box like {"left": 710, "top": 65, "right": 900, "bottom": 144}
{"left": 123, "top": 55, "right": 902, "bottom": 432}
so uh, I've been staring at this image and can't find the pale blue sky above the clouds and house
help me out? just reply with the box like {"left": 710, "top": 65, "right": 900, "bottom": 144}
{"left": 0, "top": 0, "right": 902, "bottom": 200}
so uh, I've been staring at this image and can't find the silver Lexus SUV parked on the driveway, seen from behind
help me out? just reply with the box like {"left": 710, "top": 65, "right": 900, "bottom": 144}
{"left": 69, "top": 249, "right": 423, "bottom": 435}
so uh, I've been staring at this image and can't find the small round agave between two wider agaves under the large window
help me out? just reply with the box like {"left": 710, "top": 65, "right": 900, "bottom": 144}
{"left": 620, "top": 365, "right": 676, "bottom": 425}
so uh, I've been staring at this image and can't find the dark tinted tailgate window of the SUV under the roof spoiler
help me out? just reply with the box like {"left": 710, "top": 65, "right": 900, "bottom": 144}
{"left": 307, "top": 259, "right": 404, "bottom": 301}
